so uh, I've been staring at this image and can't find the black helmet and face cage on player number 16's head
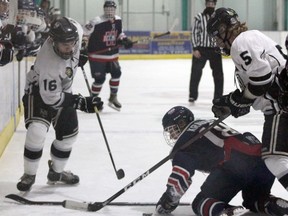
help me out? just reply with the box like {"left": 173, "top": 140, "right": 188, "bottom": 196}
{"left": 49, "top": 17, "right": 79, "bottom": 60}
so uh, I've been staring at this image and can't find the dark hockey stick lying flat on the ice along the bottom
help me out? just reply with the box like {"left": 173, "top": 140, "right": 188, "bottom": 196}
{"left": 5, "top": 194, "right": 190, "bottom": 206}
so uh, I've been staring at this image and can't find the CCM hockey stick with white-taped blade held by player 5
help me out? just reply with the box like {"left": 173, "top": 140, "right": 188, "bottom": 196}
{"left": 25, "top": 114, "right": 230, "bottom": 212}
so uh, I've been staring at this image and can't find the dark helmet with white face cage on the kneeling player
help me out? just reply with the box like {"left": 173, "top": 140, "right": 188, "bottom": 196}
{"left": 162, "top": 106, "right": 194, "bottom": 146}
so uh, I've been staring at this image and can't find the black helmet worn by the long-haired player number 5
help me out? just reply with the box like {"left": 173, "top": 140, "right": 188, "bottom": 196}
{"left": 207, "top": 7, "right": 240, "bottom": 37}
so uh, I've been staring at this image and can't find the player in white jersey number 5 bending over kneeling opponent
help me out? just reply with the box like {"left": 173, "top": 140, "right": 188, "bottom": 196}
{"left": 207, "top": 8, "right": 288, "bottom": 194}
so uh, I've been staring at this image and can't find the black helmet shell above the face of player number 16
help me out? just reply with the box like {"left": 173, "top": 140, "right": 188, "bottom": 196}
{"left": 49, "top": 17, "right": 79, "bottom": 43}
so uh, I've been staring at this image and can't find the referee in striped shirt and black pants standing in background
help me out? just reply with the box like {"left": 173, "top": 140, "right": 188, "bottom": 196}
{"left": 189, "top": 0, "right": 224, "bottom": 103}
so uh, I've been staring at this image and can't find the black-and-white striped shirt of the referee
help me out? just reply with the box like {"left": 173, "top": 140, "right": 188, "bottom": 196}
{"left": 191, "top": 13, "right": 216, "bottom": 50}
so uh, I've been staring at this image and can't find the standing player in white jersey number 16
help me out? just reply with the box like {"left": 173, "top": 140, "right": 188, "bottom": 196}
{"left": 17, "top": 17, "right": 103, "bottom": 191}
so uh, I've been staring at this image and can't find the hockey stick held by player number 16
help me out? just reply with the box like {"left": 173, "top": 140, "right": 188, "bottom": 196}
{"left": 81, "top": 66, "right": 125, "bottom": 179}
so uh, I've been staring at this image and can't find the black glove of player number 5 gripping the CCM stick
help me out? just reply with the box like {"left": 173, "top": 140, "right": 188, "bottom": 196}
{"left": 212, "top": 89, "right": 254, "bottom": 118}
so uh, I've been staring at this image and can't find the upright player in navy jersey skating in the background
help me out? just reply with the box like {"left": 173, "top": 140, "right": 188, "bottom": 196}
{"left": 83, "top": 1, "right": 133, "bottom": 111}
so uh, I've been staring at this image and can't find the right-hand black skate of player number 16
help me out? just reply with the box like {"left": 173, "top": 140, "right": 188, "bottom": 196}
{"left": 47, "top": 160, "right": 79, "bottom": 185}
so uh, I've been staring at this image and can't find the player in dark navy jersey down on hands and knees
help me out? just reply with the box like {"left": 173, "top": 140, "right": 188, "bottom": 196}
{"left": 156, "top": 106, "right": 288, "bottom": 216}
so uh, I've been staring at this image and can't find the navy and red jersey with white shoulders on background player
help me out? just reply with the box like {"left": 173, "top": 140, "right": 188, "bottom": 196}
{"left": 83, "top": 15, "right": 126, "bottom": 62}
